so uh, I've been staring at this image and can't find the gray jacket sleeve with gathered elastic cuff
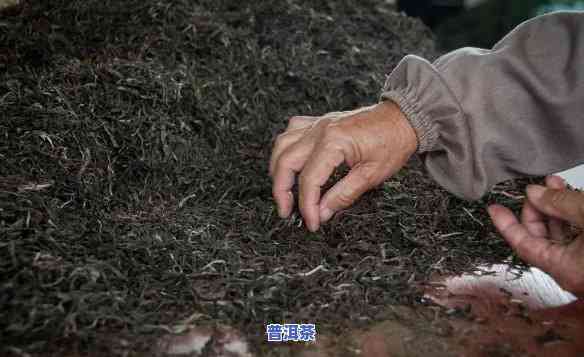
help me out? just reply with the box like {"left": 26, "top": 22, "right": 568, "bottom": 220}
{"left": 382, "top": 12, "right": 584, "bottom": 200}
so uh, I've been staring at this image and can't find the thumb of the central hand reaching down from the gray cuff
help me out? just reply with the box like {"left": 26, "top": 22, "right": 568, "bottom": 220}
{"left": 320, "top": 165, "right": 376, "bottom": 222}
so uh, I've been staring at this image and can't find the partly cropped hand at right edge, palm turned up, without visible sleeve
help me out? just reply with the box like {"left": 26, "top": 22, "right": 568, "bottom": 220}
{"left": 488, "top": 176, "right": 584, "bottom": 298}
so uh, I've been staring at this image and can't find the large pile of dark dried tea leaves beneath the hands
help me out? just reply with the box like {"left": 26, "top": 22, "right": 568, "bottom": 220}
{"left": 0, "top": 0, "right": 540, "bottom": 355}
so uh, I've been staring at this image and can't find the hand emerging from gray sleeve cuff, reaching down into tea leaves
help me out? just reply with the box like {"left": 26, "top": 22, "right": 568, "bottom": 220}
{"left": 270, "top": 101, "right": 417, "bottom": 232}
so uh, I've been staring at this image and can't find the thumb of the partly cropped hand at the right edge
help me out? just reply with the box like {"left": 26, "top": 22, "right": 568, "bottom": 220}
{"left": 527, "top": 185, "right": 584, "bottom": 227}
